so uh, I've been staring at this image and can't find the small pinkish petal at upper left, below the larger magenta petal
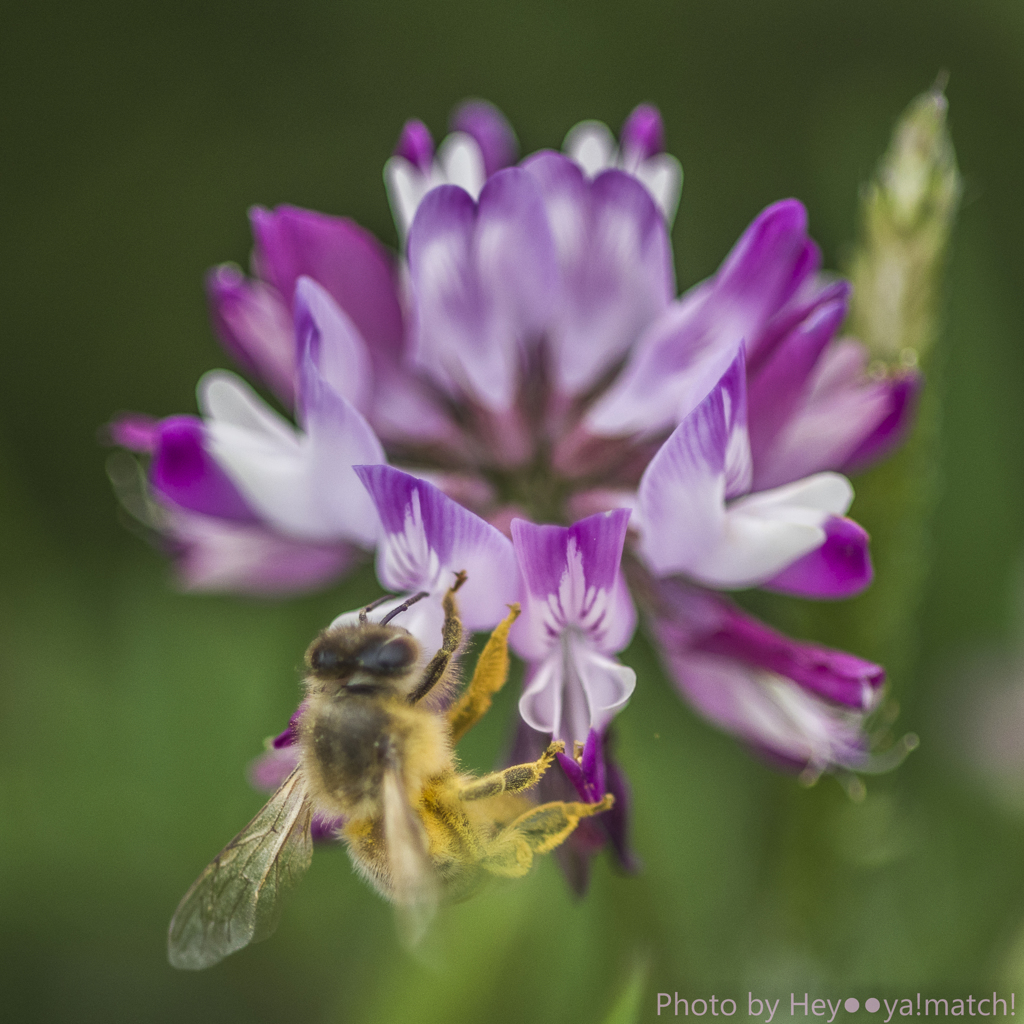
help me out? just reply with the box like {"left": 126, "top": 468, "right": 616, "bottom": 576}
{"left": 206, "top": 263, "right": 295, "bottom": 406}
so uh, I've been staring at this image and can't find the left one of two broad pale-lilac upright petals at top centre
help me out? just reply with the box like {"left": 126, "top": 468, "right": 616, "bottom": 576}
{"left": 409, "top": 168, "right": 557, "bottom": 411}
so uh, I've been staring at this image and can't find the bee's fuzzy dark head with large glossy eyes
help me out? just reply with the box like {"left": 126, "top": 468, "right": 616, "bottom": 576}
{"left": 306, "top": 623, "right": 420, "bottom": 693}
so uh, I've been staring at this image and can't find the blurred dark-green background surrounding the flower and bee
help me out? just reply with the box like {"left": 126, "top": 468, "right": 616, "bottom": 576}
{"left": 0, "top": 0, "right": 1024, "bottom": 1022}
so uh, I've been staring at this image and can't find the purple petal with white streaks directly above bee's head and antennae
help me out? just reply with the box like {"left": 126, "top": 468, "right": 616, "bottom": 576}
{"left": 355, "top": 465, "right": 518, "bottom": 636}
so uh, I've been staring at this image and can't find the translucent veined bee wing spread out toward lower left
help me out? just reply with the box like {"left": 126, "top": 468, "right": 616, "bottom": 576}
{"left": 167, "top": 769, "right": 313, "bottom": 971}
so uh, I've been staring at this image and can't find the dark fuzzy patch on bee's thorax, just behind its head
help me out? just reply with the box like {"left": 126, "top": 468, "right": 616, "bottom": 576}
{"left": 310, "top": 698, "right": 394, "bottom": 805}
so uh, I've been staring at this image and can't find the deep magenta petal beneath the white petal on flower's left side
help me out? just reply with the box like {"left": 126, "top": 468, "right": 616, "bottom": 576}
{"left": 150, "top": 416, "right": 256, "bottom": 522}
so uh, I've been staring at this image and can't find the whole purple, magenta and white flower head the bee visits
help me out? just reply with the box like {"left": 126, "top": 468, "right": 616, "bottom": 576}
{"left": 113, "top": 101, "right": 920, "bottom": 880}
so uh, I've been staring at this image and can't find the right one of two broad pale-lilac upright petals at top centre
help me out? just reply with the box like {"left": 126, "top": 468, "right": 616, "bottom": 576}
{"left": 523, "top": 153, "right": 675, "bottom": 394}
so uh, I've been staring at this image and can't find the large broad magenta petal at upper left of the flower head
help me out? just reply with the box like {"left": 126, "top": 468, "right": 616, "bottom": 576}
{"left": 250, "top": 206, "right": 402, "bottom": 362}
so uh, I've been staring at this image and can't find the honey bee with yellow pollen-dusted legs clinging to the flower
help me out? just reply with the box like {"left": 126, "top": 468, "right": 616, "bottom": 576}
{"left": 168, "top": 572, "right": 613, "bottom": 970}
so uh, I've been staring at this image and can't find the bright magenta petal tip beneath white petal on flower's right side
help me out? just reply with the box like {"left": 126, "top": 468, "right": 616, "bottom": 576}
{"left": 763, "top": 516, "right": 874, "bottom": 598}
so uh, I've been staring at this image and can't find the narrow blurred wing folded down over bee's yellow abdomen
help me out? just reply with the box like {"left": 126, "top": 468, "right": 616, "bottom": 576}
{"left": 384, "top": 768, "right": 440, "bottom": 946}
